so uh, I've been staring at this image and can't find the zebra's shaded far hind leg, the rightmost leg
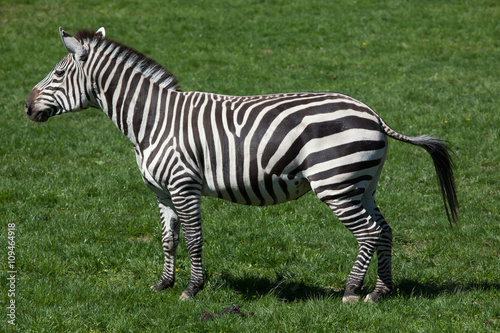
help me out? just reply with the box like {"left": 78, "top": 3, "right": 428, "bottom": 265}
{"left": 364, "top": 196, "right": 393, "bottom": 303}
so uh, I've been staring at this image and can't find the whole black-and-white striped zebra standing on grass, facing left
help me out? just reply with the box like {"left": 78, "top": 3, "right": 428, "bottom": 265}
{"left": 25, "top": 28, "right": 458, "bottom": 302}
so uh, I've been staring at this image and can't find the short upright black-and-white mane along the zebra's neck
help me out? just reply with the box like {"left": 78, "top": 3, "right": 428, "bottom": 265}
{"left": 75, "top": 30, "right": 179, "bottom": 90}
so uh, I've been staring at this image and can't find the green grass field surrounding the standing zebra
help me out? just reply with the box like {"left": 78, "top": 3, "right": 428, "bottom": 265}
{"left": 0, "top": 0, "right": 500, "bottom": 332}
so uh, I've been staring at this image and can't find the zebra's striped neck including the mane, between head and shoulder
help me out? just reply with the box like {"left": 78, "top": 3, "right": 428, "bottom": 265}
{"left": 82, "top": 32, "right": 182, "bottom": 145}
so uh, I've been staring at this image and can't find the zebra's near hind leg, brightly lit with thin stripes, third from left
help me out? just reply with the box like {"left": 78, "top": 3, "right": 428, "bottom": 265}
{"left": 325, "top": 198, "right": 381, "bottom": 303}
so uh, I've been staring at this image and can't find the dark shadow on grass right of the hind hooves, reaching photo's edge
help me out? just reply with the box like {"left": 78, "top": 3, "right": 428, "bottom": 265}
{"left": 395, "top": 280, "right": 500, "bottom": 299}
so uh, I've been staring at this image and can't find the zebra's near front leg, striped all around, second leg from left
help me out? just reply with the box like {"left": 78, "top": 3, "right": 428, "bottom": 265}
{"left": 172, "top": 188, "right": 204, "bottom": 300}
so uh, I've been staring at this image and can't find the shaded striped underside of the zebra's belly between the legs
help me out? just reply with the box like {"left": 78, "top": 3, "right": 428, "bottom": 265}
{"left": 202, "top": 175, "right": 311, "bottom": 206}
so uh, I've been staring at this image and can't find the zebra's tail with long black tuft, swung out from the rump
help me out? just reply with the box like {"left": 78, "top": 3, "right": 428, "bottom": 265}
{"left": 381, "top": 119, "right": 458, "bottom": 225}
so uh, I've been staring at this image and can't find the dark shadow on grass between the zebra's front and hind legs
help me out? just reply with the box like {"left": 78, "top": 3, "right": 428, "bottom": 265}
{"left": 217, "top": 274, "right": 344, "bottom": 302}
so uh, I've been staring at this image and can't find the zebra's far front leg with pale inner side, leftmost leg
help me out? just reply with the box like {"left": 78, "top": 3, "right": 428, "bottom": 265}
{"left": 151, "top": 199, "right": 180, "bottom": 291}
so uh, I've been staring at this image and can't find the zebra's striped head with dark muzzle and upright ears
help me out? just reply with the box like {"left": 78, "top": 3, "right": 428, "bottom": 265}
{"left": 24, "top": 28, "right": 105, "bottom": 122}
